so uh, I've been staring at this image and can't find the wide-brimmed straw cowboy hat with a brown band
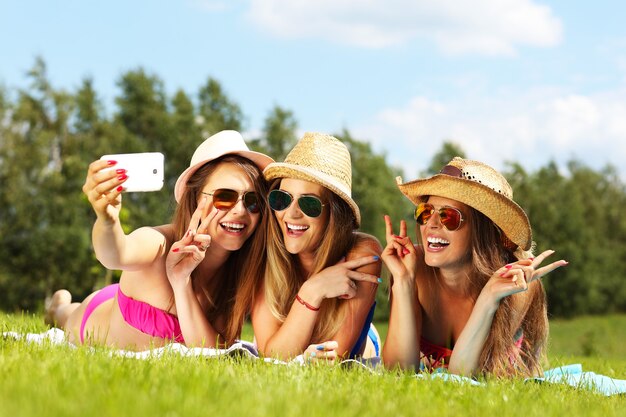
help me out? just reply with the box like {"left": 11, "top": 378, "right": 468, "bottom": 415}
{"left": 396, "top": 157, "right": 532, "bottom": 250}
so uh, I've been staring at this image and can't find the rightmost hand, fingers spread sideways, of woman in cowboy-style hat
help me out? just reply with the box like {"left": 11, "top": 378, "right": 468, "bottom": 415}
{"left": 483, "top": 250, "right": 568, "bottom": 303}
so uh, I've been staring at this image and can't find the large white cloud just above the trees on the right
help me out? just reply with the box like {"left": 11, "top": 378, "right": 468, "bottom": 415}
{"left": 351, "top": 89, "right": 626, "bottom": 178}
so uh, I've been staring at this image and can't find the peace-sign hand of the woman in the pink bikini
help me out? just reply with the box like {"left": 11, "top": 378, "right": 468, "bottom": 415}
{"left": 165, "top": 197, "right": 218, "bottom": 290}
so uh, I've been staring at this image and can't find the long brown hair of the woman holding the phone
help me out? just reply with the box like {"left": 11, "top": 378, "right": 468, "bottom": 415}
{"left": 172, "top": 155, "right": 270, "bottom": 346}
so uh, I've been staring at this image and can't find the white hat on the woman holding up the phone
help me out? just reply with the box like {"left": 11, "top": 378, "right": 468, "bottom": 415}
{"left": 174, "top": 130, "right": 274, "bottom": 202}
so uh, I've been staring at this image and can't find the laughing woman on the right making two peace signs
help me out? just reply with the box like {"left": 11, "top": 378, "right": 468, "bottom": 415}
{"left": 382, "top": 157, "right": 567, "bottom": 376}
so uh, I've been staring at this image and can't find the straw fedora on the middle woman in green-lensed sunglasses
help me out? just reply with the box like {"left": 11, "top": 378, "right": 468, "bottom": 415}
{"left": 263, "top": 132, "right": 361, "bottom": 227}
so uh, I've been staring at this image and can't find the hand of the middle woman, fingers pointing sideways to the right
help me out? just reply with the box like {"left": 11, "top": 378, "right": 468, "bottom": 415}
{"left": 299, "top": 256, "right": 381, "bottom": 307}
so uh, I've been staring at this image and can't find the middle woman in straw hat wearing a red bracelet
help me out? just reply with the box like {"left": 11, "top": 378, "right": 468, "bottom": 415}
{"left": 252, "top": 133, "right": 382, "bottom": 361}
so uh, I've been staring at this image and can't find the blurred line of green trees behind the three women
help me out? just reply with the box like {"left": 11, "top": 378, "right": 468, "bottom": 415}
{"left": 0, "top": 58, "right": 626, "bottom": 320}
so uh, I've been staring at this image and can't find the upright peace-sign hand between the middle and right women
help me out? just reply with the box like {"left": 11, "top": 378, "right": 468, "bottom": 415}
{"left": 381, "top": 215, "right": 417, "bottom": 282}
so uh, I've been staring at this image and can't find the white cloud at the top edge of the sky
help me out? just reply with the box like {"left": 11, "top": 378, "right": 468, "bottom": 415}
{"left": 248, "top": 0, "right": 562, "bottom": 55}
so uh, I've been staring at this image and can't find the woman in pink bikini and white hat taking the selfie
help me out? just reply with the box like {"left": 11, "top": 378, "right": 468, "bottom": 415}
{"left": 47, "top": 131, "right": 272, "bottom": 350}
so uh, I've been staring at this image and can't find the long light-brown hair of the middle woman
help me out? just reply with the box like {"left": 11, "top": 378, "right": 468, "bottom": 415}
{"left": 264, "top": 179, "right": 358, "bottom": 342}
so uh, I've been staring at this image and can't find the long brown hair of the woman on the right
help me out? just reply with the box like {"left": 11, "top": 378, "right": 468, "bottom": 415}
{"left": 460, "top": 207, "right": 548, "bottom": 376}
